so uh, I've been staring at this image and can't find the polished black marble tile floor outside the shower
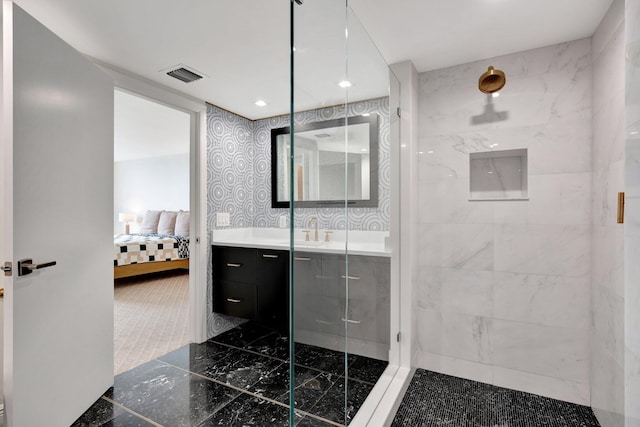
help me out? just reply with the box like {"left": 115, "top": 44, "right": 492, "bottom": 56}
{"left": 73, "top": 322, "right": 387, "bottom": 427}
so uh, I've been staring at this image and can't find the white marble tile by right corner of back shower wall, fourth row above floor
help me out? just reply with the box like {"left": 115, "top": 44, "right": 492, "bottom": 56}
{"left": 494, "top": 224, "right": 591, "bottom": 277}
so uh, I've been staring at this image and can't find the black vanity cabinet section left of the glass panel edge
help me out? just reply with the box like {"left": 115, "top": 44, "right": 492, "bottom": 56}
{"left": 212, "top": 246, "right": 289, "bottom": 330}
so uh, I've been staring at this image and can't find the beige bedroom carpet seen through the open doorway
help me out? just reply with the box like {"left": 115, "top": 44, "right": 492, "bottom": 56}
{"left": 114, "top": 272, "right": 189, "bottom": 375}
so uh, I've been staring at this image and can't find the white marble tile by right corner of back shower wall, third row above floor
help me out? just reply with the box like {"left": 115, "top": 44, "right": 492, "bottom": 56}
{"left": 493, "top": 272, "right": 591, "bottom": 330}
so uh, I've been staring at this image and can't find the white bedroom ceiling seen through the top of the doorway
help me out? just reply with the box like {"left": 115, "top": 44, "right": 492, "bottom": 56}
{"left": 113, "top": 90, "right": 191, "bottom": 162}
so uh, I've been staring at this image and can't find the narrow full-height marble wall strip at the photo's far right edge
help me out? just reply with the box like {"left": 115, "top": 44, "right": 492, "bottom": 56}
{"left": 623, "top": 0, "right": 640, "bottom": 427}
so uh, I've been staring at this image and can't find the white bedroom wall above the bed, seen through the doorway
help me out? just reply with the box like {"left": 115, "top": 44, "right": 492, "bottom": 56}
{"left": 113, "top": 154, "right": 189, "bottom": 233}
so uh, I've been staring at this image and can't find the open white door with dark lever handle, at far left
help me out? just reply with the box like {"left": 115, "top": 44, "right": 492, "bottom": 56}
{"left": 1, "top": 0, "right": 113, "bottom": 427}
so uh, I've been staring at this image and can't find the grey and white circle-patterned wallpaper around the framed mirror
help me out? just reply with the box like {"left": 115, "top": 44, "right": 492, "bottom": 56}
{"left": 207, "top": 98, "right": 391, "bottom": 337}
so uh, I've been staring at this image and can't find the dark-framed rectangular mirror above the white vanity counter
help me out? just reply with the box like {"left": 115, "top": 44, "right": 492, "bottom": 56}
{"left": 271, "top": 114, "right": 378, "bottom": 208}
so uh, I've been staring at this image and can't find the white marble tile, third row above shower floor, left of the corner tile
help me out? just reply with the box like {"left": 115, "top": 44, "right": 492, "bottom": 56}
{"left": 440, "top": 269, "right": 493, "bottom": 317}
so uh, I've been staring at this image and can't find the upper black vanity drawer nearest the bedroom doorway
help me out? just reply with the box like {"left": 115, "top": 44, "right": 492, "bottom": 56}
{"left": 213, "top": 246, "right": 256, "bottom": 284}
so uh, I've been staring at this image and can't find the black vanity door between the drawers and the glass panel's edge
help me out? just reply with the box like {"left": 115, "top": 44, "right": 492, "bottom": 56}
{"left": 256, "top": 249, "right": 289, "bottom": 330}
